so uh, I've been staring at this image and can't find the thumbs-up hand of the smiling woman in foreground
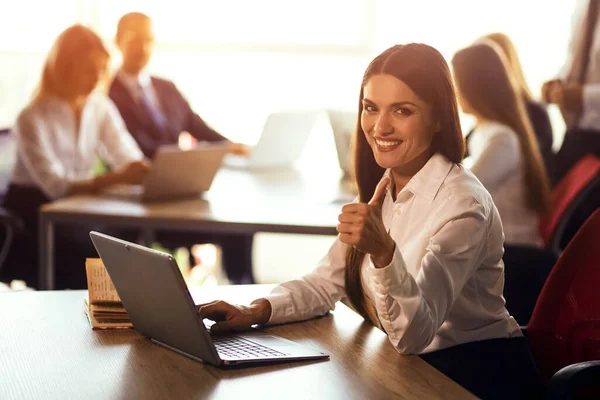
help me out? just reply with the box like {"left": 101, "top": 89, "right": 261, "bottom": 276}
{"left": 337, "top": 177, "right": 396, "bottom": 268}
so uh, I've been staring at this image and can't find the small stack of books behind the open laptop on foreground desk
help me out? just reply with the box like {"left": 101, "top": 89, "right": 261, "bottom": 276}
{"left": 84, "top": 258, "right": 133, "bottom": 329}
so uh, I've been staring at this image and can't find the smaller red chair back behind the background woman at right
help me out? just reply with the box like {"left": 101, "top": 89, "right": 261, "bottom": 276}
{"left": 539, "top": 154, "right": 600, "bottom": 250}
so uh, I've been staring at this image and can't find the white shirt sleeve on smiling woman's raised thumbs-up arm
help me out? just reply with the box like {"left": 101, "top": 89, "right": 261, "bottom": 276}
{"left": 369, "top": 196, "right": 489, "bottom": 354}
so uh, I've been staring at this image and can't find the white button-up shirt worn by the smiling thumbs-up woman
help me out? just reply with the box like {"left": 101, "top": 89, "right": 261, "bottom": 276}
{"left": 266, "top": 154, "right": 522, "bottom": 354}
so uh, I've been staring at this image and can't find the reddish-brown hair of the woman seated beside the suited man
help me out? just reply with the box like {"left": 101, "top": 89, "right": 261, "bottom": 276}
{"left": 33, "top": 24, "right": 109, "bottom": 100}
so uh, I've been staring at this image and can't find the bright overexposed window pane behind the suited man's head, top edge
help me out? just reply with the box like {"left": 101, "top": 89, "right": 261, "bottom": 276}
{"left": 95, "top": 0, "right": 372, "bottom": 48}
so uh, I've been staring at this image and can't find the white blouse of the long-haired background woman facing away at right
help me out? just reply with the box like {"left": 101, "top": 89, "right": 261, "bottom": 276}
{"left": 469, "top": 122, "right": 542, "bottom": 247}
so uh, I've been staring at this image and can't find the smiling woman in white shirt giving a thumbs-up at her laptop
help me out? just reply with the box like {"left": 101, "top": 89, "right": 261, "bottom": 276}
{"left": 199, "top": 44, "right": 539, "bottom": 398}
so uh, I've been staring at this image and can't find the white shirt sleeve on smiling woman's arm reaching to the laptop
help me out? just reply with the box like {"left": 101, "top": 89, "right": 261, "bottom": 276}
{"left": 265, "top": 239, "right": 348, "bottom": 324}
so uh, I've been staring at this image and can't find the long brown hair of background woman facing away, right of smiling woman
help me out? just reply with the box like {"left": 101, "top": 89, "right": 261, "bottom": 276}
{"left": 452, "top": 40, "right": 550, "bottom": 215}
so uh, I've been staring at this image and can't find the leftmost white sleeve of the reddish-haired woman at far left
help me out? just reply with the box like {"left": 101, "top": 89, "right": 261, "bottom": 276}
{"left": 14, "top": 113, "right": 70, "bottom": 199}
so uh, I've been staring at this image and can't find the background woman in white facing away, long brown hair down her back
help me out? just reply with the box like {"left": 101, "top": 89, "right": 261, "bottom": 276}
{"left": 452, "top": 40, "right": 550, "bottom": 246}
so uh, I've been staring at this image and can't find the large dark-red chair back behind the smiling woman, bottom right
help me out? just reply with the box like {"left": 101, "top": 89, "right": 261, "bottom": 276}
{"left": 527, "top": 210, "right": 600, "bottom": 379}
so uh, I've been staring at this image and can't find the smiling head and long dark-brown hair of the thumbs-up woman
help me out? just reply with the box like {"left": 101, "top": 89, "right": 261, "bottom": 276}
{"left": 342, "top": 44, "right": 464, "bottom": 321}
